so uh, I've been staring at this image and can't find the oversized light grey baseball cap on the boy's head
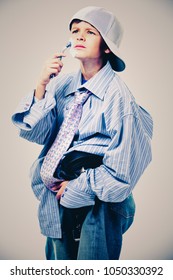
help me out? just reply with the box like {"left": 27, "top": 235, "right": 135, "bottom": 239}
{"left": 69, "top": 6, "right": 126, "bottom": 72}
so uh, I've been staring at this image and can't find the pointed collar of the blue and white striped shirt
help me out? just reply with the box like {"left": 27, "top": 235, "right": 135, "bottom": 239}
{"left": 65, "top": 62, "right": 115, "bottom": 100}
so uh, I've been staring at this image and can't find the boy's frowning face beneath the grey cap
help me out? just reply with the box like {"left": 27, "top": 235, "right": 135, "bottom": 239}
{"left": 71, "top": 21, "right": 107, "bottom": 61}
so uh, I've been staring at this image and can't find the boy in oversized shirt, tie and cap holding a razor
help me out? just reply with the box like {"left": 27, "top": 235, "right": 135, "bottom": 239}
{"left": 12, "top": 7, "right": 153, "bottom": 260}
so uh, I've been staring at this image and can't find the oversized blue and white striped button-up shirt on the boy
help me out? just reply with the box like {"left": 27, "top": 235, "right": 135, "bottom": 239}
{"left": 12, "top": 62, "right": 153, "bottom": 238}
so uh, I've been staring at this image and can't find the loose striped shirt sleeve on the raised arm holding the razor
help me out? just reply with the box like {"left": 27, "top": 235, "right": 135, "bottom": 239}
{"left": 12, "top": 87, "right": 56, "bottom": 144}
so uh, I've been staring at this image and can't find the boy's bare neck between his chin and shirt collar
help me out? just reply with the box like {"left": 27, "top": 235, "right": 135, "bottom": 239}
{"left": 80, "top": 60, "right": 104, "bottom": 80}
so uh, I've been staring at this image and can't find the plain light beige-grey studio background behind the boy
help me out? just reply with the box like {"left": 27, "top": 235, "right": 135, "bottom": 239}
{"left": 0, "top": 0, "right": 173, "bottom": 260}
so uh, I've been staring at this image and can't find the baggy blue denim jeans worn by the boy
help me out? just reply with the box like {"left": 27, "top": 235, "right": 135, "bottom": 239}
{"left": 46, "top": 192, "right": 135, "bottom": 260}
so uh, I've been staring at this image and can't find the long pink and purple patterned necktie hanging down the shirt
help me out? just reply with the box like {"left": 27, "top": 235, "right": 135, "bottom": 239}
{"left": 40, "top": 91, "right": 89, "bottom": 189}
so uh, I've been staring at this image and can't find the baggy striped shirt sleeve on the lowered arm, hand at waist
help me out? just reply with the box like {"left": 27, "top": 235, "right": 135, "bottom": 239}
{"left": 61, "top": 115, "right": 152, "bottom": 208}
